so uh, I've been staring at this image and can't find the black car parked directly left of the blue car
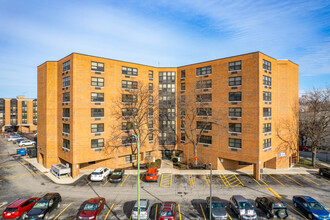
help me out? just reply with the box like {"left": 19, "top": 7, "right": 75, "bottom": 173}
{"left": 256, "top": 196, "right": 288, "bottom": 219}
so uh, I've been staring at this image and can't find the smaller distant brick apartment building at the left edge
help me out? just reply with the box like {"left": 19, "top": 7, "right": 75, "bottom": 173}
{"left": 0, "top": 96, "right": 37, "bottom": 133}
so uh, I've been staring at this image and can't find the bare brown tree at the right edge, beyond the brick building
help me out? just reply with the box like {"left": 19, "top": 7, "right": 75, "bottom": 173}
{"left": 300, "top": 88, "right": 330, "bottom": 166}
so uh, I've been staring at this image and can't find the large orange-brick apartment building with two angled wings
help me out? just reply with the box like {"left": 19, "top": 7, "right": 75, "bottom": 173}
{"left": 38, "top": 52, "right": 299, "bottom": 178}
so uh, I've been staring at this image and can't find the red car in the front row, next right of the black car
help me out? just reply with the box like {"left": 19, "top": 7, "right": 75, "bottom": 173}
{"left": 79, "top": 197, "right": 105, "bottom": 219}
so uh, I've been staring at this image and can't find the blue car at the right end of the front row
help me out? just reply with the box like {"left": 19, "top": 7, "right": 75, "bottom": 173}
{"left": 292, "top": 196, "right": 330, "bottom": 219}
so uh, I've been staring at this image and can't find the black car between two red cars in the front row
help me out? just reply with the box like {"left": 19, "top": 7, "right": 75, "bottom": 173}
{"left": 25, "top": 193, "right": 62, "bottom": 220}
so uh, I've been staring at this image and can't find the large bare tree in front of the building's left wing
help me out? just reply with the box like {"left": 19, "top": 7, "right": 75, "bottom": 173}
{"left": 106, "top": 81, "right": 158, "bottom": 165}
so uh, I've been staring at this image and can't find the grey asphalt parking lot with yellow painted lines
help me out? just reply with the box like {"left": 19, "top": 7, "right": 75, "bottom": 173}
{"left": 0, "top": 137, "right": 330, "bottom": 220}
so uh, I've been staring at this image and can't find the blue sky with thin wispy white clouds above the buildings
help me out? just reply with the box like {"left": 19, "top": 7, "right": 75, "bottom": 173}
{"left": 0, "top": 0, "right": 330, "bottom": 97}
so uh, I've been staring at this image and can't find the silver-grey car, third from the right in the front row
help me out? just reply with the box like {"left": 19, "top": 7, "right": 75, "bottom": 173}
{"left": 229, "top": 195, "right": 258, "bottom": 219}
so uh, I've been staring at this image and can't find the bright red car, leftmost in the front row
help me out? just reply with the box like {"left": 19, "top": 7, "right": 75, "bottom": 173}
{"left": 2, "top": 197, "right": 40, "bottom": 219}
